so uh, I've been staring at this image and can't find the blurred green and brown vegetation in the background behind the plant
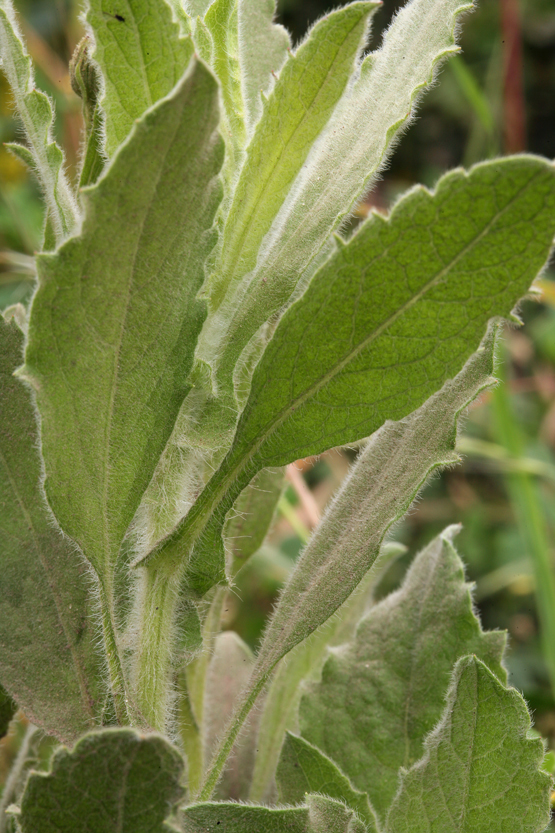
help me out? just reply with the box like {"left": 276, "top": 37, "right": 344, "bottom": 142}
{"left": 0, "top": 0, "right": 555, "bottom": 808}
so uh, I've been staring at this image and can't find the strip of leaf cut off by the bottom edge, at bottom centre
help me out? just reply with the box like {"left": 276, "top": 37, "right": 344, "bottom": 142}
{"left": 184, "top": 801, "right": 310, "bottom": 833}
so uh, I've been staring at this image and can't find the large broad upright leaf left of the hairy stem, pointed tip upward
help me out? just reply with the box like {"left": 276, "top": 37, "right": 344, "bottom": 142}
{"left": 24, "top": 64, "right": 222, "bottom": 592}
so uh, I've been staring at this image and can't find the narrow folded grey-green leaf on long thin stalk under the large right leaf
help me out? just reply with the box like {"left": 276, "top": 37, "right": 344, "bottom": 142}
{"left": 201, "top": 327, "right": 496, "bottom": 798}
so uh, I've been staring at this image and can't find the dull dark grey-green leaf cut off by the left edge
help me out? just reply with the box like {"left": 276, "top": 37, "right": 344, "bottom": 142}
{"left": 0, "top": 308, "right": 105, "bottom": 741}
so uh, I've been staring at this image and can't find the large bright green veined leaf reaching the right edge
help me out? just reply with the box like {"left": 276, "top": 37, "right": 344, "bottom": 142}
{"left": 153, "top": 157, "right": 555, "bottom": 592}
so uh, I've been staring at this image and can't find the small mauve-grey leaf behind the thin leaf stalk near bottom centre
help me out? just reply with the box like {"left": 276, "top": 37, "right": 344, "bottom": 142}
{"left": 203, "top": 631, "right": 258, "bottom": 801}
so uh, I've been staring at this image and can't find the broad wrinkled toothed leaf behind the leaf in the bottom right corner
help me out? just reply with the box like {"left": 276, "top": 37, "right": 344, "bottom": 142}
{"left": 300, "top": 527, "right": 507, "bottom": 820}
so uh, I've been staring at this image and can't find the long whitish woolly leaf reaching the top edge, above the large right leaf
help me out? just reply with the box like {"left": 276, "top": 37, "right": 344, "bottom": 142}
{"left": 194, "top": 0, "right": 471, "bottom": 385}
